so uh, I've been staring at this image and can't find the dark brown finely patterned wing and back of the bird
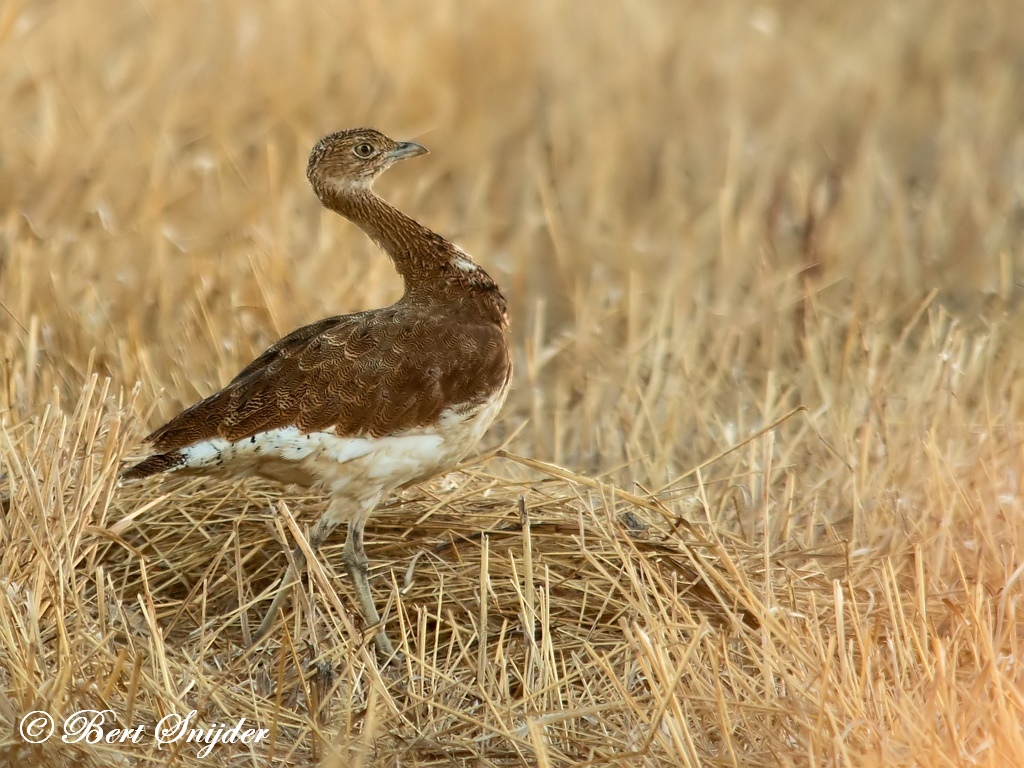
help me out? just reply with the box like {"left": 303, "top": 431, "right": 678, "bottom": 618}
{"left": 125, "top": 305, "right": 509, "bottom": 477}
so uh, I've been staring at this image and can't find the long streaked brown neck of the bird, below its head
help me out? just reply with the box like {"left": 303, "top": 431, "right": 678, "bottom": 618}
{"left": 321, "top": 186, "right": 507, "bottom": 326}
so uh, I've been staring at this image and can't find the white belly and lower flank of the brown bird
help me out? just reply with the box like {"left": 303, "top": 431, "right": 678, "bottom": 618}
{"left": 180, "top": 388, "right": 507, "bottom": 501}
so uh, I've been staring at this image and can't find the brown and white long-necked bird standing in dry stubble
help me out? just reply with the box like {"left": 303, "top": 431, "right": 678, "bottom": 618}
{"left": 122, "top": 128, "right": 512, "bottom": 657}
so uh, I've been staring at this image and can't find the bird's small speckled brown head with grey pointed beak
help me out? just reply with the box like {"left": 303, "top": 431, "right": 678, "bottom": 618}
{"left": 306, "top": 128, "right": 427, "bottom": 201}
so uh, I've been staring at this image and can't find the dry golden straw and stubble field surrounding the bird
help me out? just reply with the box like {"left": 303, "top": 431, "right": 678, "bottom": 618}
{"left": 0, "top": 0, "right": 1024, "bottom": 768}
